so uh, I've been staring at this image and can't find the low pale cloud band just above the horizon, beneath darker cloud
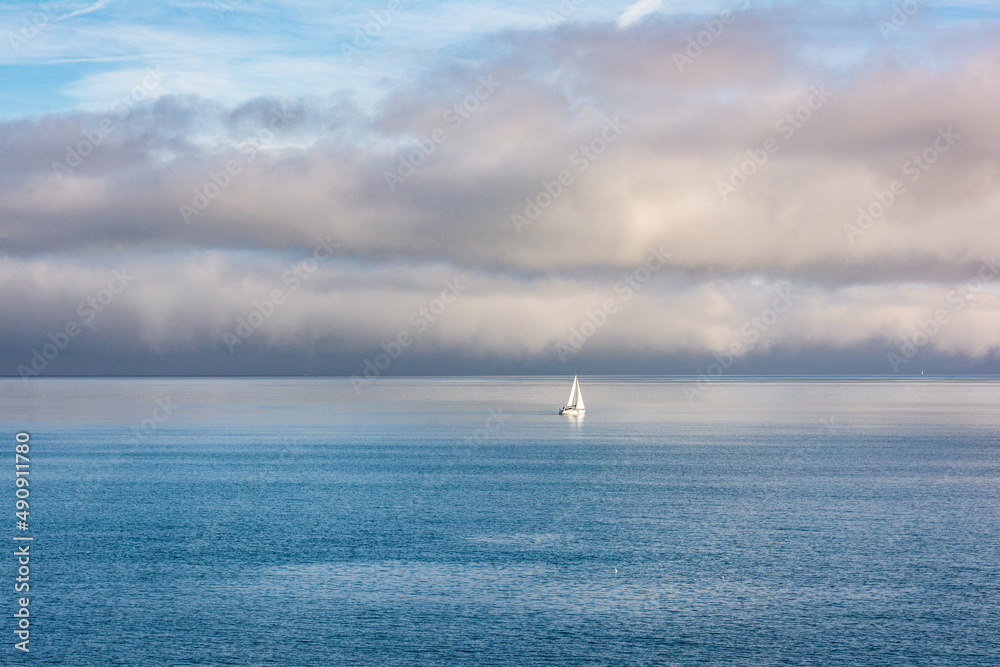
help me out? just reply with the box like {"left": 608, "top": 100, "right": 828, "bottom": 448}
{"left": 0, "top": 252, "right": 1000, "bottom": 374}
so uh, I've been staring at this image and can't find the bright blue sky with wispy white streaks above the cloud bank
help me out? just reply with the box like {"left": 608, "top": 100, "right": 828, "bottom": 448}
{"left": 0, "top": 0, "right": 1000, "bottom": 118}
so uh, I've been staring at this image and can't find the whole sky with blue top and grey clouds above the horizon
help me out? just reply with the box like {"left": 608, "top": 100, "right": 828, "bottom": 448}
{"left": 0, "top": 0, "right": 1000, "bottom": 378}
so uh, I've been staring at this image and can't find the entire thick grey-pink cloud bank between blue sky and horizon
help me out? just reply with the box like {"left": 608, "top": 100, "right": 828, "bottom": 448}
{"left": 0, "top": 4, "right": 1000, "bottom": 374}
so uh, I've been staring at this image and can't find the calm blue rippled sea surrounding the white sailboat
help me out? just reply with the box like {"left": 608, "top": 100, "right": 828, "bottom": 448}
{"left": 0, "top": 377, "right": 1000, "bottom": 665}
